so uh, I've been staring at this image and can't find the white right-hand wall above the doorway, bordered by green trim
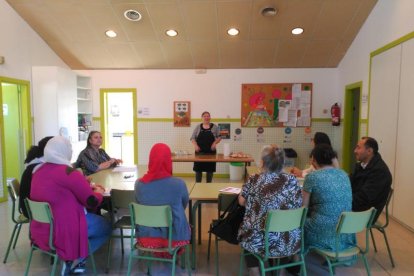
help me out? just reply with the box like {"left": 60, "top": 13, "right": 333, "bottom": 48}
{"left": 338, "top": 0, "right": 414, "bottom": 119}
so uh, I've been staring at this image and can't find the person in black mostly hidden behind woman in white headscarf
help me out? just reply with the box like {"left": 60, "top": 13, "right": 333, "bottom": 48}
{"left": 19, "top": 136, "right": 53, "bottom": 218}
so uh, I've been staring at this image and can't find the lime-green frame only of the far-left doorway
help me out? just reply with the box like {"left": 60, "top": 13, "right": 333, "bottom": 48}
{"left": 0, "top": 77, "right": 33, "bottom": 202}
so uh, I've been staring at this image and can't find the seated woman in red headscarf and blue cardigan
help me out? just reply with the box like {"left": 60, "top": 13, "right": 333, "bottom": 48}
{"left": 135, "top": 143, "right": 191, "bottom": 258}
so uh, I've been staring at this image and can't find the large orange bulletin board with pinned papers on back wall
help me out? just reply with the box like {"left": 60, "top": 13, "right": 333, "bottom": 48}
{"left": 241, "top": 83, "right": 312, "bottom": 127}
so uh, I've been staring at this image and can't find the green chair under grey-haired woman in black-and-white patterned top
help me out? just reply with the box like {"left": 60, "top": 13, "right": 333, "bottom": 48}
{"left": 239, "top": 207, "right": 308, "bottom": 276}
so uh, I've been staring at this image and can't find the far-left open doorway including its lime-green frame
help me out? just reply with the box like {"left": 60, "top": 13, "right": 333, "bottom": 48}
{"left": 0, "top": 77, "right": 32, "bottom": 201}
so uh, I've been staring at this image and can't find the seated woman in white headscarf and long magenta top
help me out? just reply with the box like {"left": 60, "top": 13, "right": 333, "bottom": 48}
{"left": 30, "top": 136, "right": 112, "bottom": 275}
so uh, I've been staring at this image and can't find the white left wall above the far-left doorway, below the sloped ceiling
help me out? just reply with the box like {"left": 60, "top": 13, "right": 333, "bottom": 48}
{"left": 0, "top": 0, "right": 67, "bottom": 80}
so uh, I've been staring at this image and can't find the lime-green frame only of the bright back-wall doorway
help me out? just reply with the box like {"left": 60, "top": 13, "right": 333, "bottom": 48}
{"left": 100, "top": 88, "right": 138, "bottom": 165}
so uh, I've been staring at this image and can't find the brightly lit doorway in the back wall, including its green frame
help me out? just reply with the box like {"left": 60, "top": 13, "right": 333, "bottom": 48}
{"left": 100, "top": 88, "right": 138, "bottom": 165}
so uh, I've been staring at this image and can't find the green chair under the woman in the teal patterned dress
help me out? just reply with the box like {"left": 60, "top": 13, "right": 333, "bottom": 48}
{"left": 312, "top": 208, "right": 376, "bottom": 275}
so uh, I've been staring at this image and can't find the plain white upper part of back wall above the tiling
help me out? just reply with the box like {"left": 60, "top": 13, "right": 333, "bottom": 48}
{"left": 80, "top": 69, "right": 342, "bottom": 118}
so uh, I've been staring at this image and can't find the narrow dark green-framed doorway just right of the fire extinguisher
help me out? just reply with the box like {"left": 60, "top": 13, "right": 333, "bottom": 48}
{"left": 342, "top": 82, "right": 362, "bottom": 173}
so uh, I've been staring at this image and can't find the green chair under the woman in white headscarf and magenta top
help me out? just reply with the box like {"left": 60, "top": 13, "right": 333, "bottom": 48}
{"left": 24, "top": 198, "right": 96, "bottom": 276}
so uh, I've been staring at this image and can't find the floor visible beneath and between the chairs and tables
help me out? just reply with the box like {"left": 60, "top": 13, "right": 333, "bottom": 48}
{"left": 0, "top": 179, "right": 414, "bottom": 276}
